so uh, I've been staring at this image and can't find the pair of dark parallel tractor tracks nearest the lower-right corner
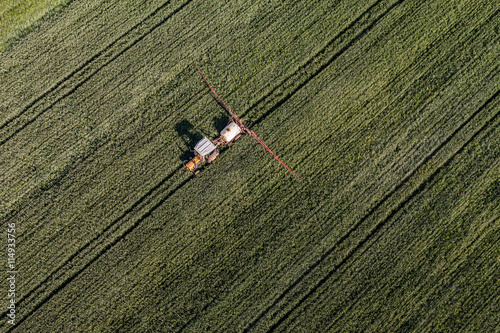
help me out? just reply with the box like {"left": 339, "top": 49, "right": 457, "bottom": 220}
{"left": 244, "top": 90, "right": 500, "bottom": 332}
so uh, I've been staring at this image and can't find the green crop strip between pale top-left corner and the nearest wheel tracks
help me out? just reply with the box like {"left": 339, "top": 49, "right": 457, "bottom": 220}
{"left": 0, "top": 2, "right": 162, "bottom": 120}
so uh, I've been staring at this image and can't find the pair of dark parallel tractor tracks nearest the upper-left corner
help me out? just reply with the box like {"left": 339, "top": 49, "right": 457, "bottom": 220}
{"left": 0, "top": 0, "right": 192, "bottom": 146}
